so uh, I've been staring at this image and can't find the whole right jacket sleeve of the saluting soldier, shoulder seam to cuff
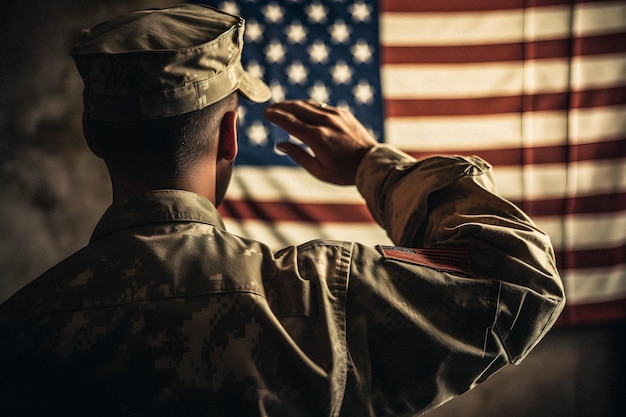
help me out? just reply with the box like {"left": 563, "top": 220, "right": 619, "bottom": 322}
{"left": 348, "top": 145, "right": 565, "bottom": 415}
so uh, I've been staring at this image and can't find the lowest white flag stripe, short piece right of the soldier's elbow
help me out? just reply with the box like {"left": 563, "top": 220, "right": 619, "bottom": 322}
{"left": 562, "top": 265, "right": 626, "bottom": 305}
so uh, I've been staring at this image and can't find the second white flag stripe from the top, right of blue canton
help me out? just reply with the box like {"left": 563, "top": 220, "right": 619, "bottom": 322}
{"left": 381, "top": 54, "right": 626, "bottom": 99}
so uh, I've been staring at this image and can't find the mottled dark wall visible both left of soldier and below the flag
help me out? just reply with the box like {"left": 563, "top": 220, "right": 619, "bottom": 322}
{"left": 0, "top": 0, "right": 626, "bottom": 417}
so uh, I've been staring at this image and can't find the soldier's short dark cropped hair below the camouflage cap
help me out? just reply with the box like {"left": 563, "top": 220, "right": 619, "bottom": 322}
{"left": 85, "top": 92, "right": 238, "bottom": 176}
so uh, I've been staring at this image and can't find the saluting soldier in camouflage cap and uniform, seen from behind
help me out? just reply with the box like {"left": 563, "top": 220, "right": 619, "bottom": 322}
{"left": 0, "top": 5, "right": 564, "bottom": 416}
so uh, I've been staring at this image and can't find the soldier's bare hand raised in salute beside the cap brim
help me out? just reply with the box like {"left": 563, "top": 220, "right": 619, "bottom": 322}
{"left": 265, "top": 100, "right": 377, "bottom": 185}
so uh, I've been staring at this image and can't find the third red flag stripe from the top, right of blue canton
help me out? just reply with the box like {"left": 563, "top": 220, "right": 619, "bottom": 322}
{"left": 384, "top": 86, "right": 626, "bottom": 118}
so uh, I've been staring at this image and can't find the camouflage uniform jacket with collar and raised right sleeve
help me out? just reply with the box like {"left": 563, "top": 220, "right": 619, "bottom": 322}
{"left": 0, "top": 145, "right": 564, "bottom": 416}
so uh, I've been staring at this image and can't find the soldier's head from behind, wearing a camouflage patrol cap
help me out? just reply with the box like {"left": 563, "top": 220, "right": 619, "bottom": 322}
{"left": 71, "top": 4, "right": 271, "bottom": 203}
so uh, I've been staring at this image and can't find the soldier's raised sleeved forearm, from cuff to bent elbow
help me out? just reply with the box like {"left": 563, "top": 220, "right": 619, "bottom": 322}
{"left": 357, "top": 146, "right": 564, "bottom": 362}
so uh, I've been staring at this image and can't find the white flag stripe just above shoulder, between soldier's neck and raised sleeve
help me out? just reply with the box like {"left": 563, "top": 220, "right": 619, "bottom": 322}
{"left": 224, "top": 219, "right": 391, "bottom": 250}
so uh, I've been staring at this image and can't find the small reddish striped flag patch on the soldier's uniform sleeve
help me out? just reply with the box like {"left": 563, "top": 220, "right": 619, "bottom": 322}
{"left": 377, "top": 245, "right": 473, "bottom": 275}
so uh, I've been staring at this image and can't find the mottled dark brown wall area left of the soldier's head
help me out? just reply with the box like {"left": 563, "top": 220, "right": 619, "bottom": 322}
{"left": 0, "top": 0, "right": 176, "bottom": 302}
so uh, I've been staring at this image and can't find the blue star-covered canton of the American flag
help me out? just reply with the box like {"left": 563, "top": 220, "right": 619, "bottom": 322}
{"left": 195, "top": 0, "right": 383, "bottom": 165}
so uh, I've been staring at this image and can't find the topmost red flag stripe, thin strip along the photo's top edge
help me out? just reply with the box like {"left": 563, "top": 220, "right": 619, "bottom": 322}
{"left": 379, "top": 0, "right": 602, "bottom": 13}
